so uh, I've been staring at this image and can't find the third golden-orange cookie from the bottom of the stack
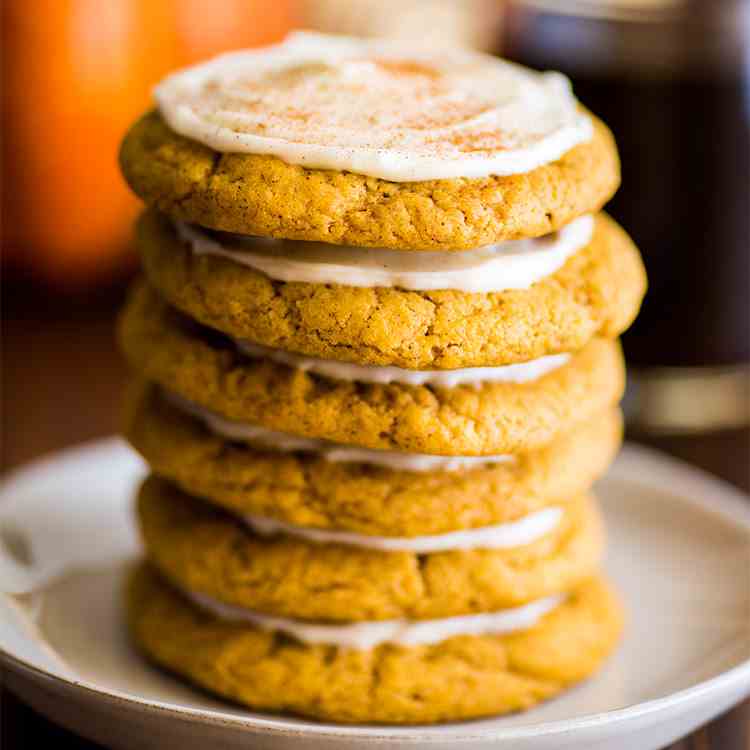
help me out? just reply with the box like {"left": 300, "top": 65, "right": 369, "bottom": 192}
{"left": 125, "top": 381, "right": 622, "bottom": 537}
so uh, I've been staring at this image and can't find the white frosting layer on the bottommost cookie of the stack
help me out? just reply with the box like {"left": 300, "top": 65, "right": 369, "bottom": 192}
{"left": 185, "top": 592, "right": 565, "bottom": 651}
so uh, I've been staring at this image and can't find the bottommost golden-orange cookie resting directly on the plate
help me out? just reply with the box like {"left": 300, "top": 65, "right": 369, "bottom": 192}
{"left": 127, "top": 565, "right": 622, "bottom": 724}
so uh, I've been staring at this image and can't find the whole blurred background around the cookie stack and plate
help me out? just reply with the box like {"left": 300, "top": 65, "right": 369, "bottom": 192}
{"left": 0, "top": 0, "right": 750, "bottom": 750}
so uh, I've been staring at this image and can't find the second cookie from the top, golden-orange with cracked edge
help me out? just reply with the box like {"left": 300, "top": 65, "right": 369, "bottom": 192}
{"left": 137, "top": 211, "right": 646, "bottom": 369}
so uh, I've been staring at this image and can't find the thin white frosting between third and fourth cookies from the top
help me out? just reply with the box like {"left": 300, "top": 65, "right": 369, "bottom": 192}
{"left": 165, "top": 393, "right": 515, "bottom": 471}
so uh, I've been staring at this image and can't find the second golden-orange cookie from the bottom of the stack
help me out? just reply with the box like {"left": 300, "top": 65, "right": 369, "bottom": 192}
{"left": 138, "top": 476, "right": 604, "bottom": 622}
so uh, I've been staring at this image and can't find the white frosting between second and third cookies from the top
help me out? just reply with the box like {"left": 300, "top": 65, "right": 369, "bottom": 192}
{"left": 237, "top": 341, "right": 570, "bottom": 388}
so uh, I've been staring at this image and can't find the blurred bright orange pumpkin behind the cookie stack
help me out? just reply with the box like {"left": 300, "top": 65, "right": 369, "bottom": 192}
{"left": 2, "top": 0, "right": 293, "bottom": 285}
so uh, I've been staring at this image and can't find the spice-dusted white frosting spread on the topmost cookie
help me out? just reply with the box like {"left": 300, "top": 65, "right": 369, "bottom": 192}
{"left": 154, "top": 32, "right": 593, "bottom": 182}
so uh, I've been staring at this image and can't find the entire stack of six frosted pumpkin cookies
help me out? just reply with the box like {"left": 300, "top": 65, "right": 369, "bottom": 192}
{"left": 120, "top": 34, "right": 645, "bottom": 723}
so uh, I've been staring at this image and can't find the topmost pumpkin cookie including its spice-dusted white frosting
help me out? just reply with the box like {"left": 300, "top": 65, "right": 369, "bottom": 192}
{"left": 120, "top": 35, "right": 619, "bottom": 250}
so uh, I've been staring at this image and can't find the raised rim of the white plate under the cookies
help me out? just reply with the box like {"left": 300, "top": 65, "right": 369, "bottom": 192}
{"left": 0, "top": 436, "right": 750, "bottom": 744}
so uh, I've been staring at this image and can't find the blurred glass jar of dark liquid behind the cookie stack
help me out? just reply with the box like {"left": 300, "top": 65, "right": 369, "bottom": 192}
{"left": 501, "top": 0, "right": 750, "bottom": 428}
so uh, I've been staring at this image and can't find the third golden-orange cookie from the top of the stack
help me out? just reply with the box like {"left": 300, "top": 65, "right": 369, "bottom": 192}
{"left": 120, "top": 285, "right": 625, "bottom": 456}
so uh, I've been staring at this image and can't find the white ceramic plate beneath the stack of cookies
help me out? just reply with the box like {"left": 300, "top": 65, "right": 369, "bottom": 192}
{"left": 0, "top": 439, "right": 750, "bottom": 750}
